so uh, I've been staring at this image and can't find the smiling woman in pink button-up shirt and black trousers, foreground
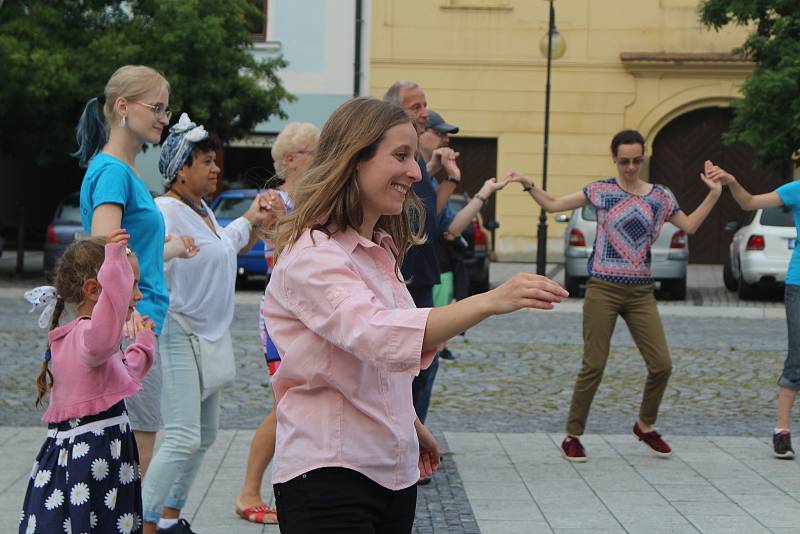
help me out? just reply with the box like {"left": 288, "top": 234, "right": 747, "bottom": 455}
{"left": 265, "top": 98, "right": 567, "bottom": 533}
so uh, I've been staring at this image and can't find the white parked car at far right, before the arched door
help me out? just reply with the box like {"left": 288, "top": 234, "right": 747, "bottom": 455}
{"left": 722, "top": 207, "right": 797, "bottom": 300}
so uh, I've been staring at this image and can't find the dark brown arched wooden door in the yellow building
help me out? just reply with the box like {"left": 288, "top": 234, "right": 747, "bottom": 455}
{"left": 650, "top": 108, "right": 783, "bottom": 263}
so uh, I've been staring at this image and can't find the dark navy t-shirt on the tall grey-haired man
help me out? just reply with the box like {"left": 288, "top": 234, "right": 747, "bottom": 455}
{"left": 401, "top": 157, "right": 441, "bottom": 288}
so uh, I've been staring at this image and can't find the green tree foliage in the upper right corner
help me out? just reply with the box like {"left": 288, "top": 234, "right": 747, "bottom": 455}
{"left": 700, "top": 0, "right": 800, "bottom": 169}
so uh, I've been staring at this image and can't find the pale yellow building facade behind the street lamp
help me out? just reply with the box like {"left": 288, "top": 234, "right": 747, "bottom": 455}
{"left": 370, "top": 0, "right": 753, "bottom": 259}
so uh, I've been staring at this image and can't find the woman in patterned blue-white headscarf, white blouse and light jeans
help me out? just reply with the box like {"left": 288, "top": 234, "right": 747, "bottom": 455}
{"left": 142, "top": 113, "right": 279, "bottom": 534}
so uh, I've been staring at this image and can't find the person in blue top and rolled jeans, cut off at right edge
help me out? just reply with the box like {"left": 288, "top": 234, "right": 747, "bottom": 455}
{"left": 708, "top": 166, "right": 800, "bottom": 460}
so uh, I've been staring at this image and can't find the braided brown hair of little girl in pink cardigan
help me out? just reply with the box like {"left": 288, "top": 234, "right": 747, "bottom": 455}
{"left": 36, "top": 237, "right": 106, "bottom": 407}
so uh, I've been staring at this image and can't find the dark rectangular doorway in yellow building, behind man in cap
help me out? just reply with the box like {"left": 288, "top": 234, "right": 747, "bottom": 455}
{"left": 437, "top": 137, "right": 497, "bottom": 227}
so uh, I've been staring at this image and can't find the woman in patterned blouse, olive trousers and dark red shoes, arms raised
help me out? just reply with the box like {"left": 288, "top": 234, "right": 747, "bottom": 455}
{"left": 507, "top": 130, "right": 722, "bottom": 462}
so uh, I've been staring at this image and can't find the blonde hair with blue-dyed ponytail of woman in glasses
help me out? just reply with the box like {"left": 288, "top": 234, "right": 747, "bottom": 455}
{"left": 72, "top": 65, "right": 169, "bottom": 167}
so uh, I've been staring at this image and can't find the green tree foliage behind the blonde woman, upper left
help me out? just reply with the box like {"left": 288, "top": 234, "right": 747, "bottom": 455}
{"left": 0, "top": 0, "right": 294, "bottom": 168}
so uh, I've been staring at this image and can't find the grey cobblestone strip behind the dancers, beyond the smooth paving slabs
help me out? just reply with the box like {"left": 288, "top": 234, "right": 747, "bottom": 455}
{"left": 0, "top": 299, "right": 786, "bottom": 435}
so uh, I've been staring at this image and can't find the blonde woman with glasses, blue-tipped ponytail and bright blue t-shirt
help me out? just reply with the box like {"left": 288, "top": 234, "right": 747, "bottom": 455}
{"left": 74, "top": 65, "right": 197, "bottom": 482}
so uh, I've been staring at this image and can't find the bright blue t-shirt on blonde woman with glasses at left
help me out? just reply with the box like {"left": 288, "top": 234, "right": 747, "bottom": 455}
{"left": 81, "top": 153, "right": 169, "bottom": 335}
